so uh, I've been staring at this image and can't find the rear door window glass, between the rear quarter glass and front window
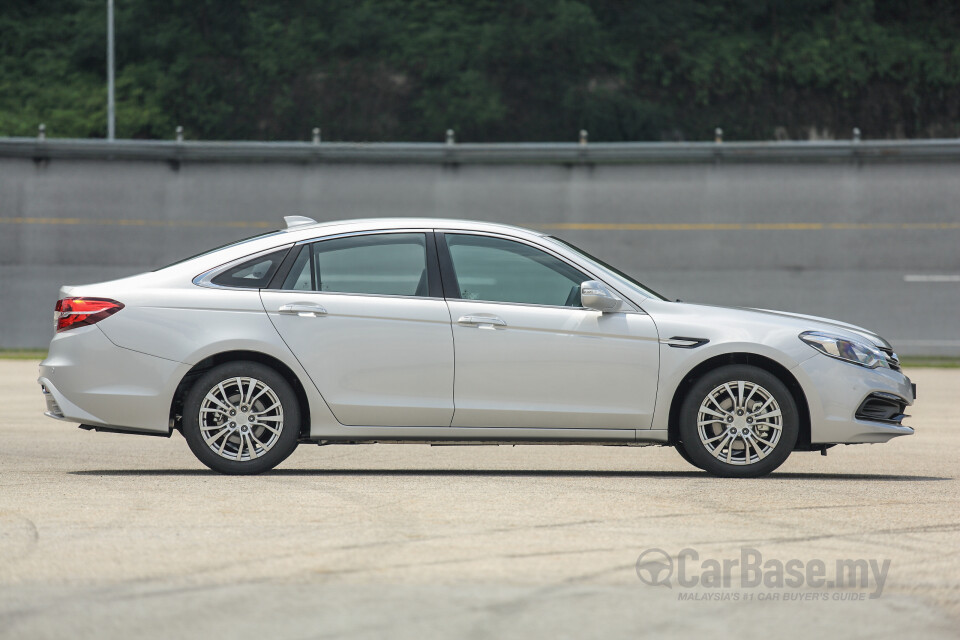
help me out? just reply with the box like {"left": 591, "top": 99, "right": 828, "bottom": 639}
{"left": 283, "top": 233, "right": 430, "bottom": 296}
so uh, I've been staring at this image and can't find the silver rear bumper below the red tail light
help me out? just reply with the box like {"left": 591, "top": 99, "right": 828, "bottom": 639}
{"left": 37, "top": 326, "right": 190, "bottom": 434}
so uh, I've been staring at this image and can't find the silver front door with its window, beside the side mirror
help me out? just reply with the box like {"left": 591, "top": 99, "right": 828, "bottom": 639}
{"left": 440, "top": 233, "right": 659, "bottom": 429}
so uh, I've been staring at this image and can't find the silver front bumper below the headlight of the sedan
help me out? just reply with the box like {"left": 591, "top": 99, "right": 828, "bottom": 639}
{"left": 792, "top": 354, "right": 916, "bottom": 444}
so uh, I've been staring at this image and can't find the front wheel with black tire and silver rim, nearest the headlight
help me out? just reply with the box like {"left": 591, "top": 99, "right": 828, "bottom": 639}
{"left": 679, "top": 365, "right": 800, "bottom": 478}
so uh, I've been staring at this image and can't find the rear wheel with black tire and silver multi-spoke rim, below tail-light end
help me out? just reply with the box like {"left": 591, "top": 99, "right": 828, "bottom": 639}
{"left": 183, "top": 361, "right": 300, "bottom": 475}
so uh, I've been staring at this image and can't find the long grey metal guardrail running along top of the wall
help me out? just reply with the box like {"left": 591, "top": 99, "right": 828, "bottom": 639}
{"left": 0, "top": 137, "right": 960, "bottom": 165}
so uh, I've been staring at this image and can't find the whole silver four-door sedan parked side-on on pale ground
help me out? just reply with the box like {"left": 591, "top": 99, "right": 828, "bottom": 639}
{"left": 39, "top": 216, "right": 915, "bottom": 477}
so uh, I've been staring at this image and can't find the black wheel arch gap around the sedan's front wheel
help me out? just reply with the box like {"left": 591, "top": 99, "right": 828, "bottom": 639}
{"left": 667, "top": 352, "right": 811, "bottom": 451}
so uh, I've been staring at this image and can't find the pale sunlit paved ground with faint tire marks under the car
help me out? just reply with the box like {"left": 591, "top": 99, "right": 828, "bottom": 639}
{"left": 0, "top": 361, "right": 960, "bottom": 639}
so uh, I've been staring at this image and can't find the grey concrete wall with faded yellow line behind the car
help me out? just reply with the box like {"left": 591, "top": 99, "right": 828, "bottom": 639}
{"left": 0, "top": 157, "right": 960, "bottom": 354}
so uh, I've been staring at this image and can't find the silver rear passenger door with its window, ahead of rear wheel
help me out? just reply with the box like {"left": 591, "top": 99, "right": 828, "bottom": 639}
{"left": 261, "top": 231, "right": 453, "bottom": 427}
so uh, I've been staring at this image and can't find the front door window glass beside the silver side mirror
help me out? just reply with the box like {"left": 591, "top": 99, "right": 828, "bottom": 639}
{"left": 446, "top": 234, "right": 590, "bottom": 307}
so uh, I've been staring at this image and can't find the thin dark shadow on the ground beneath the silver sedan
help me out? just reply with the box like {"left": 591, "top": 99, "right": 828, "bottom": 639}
{"left": 69, "top": 469, "right": 953, "bottom": 482}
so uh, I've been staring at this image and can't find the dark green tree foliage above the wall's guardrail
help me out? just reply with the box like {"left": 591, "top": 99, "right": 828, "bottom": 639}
{"left": 0, "top": 0, "right": 960, "bottom": 141}
